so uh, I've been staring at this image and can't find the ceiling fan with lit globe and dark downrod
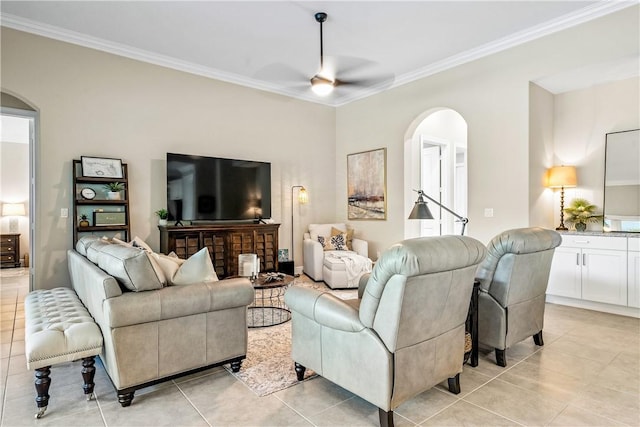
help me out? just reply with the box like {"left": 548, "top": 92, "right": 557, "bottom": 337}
{"left": 309, "top": 12, "right": 393, "bottom": 96}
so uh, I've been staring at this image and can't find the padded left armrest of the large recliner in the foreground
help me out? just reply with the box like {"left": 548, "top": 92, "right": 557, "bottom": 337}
{"left": 284, "top": 287, "right": 365, "bottom": 332}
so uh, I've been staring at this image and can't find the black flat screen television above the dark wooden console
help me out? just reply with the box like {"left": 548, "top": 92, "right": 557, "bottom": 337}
{"left": 167, "top": 153, "right": 271, "bottom": 223}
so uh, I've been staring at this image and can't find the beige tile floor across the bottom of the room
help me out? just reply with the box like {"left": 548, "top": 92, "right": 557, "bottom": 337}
{"left": 0, "top": 270, "right": 640, "bottom": 426}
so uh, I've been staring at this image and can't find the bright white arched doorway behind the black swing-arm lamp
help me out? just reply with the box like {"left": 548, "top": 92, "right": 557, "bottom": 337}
{"left": 404, "top": 108, "right": 467, "bottom": 238}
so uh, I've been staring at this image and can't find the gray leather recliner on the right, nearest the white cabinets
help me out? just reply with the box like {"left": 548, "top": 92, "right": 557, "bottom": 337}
{"left": 476, "top": 228, "right": 562, "bottom": 367}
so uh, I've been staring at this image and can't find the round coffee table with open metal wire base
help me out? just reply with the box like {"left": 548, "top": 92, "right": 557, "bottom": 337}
{"left": 247, "top": 273, "right": 295, "bottom": 328}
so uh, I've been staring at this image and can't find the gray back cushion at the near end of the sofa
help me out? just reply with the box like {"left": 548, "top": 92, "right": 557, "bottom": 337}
{"left": 97, "top": 242, "right": 162, "bottom": 292}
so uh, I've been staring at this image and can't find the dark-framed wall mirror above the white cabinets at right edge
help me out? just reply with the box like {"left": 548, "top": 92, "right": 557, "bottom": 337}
{"left": 604, "top": 129, "right": 640, "bottom": 233}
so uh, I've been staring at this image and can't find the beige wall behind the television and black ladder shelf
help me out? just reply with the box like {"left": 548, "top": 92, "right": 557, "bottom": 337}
{"left": 1, "top": 28, "right": 335, "bottom": 288}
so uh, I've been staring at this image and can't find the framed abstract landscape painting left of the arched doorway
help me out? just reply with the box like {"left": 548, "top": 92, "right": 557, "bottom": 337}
{"left": 347, "top": 148, "right": 387, "bottom": 220}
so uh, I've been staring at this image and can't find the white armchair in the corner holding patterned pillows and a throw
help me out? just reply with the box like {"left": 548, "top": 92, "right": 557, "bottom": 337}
{"left": 302, "top": 223, "right": 371, "bottom": 289}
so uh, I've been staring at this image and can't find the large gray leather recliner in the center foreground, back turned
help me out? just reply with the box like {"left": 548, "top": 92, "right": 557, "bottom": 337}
{"left": 285, "top": 236, "right": 486, "bottom": 426}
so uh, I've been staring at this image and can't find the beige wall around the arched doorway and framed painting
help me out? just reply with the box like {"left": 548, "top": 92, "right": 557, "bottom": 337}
{"left": 335, "top": 6, "right": 640, "bottom": 254}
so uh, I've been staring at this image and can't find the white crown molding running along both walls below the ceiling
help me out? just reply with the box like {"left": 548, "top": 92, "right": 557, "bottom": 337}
{"left": 0, "top": 0, "right": 640, "bottom": 107}
